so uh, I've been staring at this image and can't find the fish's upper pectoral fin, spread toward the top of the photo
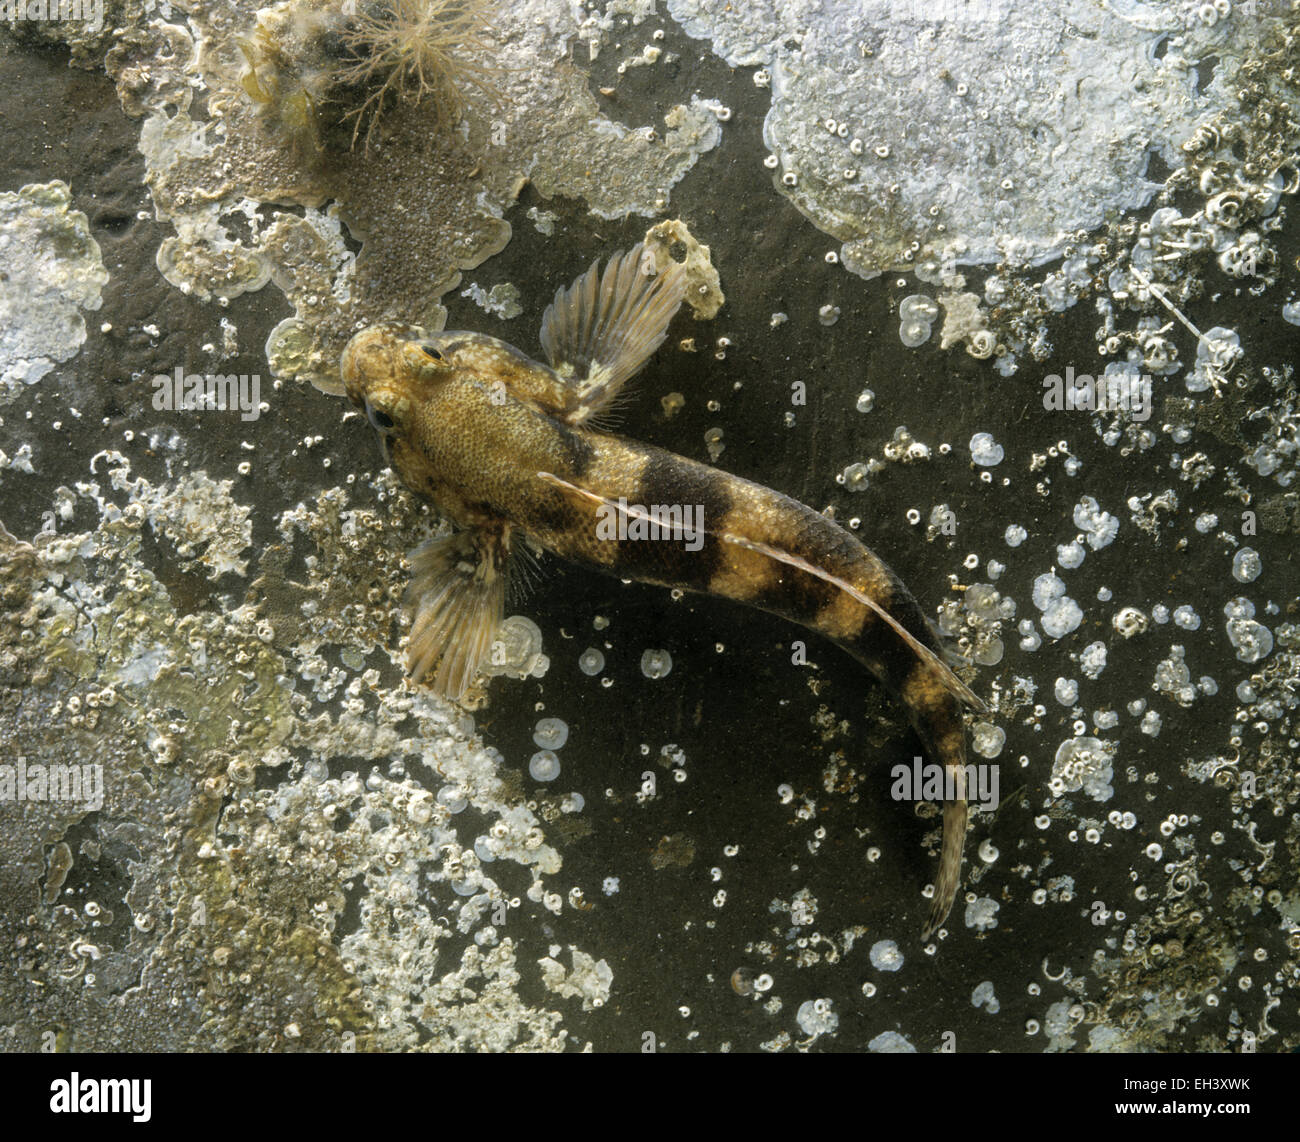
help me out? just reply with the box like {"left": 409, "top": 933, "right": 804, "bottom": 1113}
{"left": 542, "top": 243, "right": 686, "bottom": 424}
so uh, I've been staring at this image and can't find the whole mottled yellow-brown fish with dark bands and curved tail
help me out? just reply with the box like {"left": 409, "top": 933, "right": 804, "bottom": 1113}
{"left": 339, "top": 243, "right": 984, "bottom": 939}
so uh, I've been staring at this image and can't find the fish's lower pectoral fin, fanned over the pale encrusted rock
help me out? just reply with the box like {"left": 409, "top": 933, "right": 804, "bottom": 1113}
{"left": 406, "top": 529, "right": 508, "bottom": 702}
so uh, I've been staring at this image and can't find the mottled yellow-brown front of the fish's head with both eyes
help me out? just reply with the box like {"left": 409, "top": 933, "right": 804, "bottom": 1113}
{"left": 339, "top": 323, "right": 455, "bottom": 442}
